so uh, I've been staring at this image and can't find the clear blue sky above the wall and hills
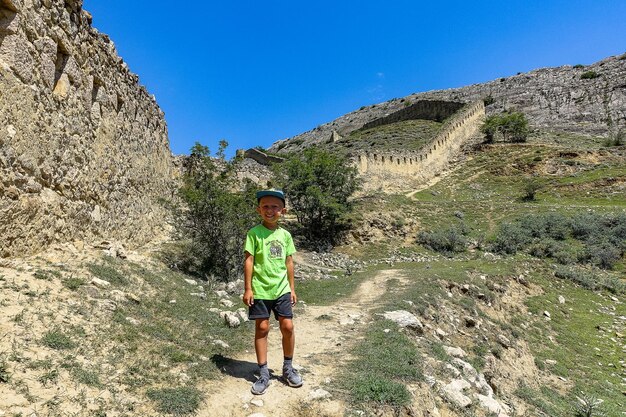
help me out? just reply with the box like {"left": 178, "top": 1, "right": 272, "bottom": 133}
{"left": 83, "top": 0, "right": 626, "bottom": 155}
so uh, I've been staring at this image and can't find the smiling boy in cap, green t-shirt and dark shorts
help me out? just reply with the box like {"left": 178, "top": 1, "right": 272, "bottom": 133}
{"left": 243, "top": 189, "right": 302, "bottom": 395}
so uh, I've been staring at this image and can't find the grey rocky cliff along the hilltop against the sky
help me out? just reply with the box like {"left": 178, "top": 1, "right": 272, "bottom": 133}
{"left": 270, "top": 54, "right": 626, "bottom": 152}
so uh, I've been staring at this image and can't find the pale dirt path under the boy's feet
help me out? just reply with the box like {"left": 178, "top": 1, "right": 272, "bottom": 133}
{"left": 197, "top": 270, "right": 401, "bottom": 417}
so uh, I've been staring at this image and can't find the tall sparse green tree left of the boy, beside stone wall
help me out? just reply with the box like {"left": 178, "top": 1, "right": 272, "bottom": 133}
{"left": 176, "top": 141, "right": 257, "bottom": 280}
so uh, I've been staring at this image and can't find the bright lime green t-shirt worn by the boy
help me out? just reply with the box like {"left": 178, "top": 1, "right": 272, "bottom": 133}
{"left": 244, "top": 224, "right": 296, "bottom": 300}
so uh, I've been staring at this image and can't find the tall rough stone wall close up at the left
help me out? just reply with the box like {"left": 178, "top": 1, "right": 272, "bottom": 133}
{"left": 0, "top": 0, "right": 176, "bottom": 257}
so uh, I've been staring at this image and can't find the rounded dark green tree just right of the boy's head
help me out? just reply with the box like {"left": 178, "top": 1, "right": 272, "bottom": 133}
{"left": 272, "top": 148, "right": 360, "bottom": 243}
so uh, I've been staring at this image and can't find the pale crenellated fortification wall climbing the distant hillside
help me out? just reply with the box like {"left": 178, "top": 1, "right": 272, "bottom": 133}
{"left": 354, "top": 100, "right": 485, "bottom": 189}
